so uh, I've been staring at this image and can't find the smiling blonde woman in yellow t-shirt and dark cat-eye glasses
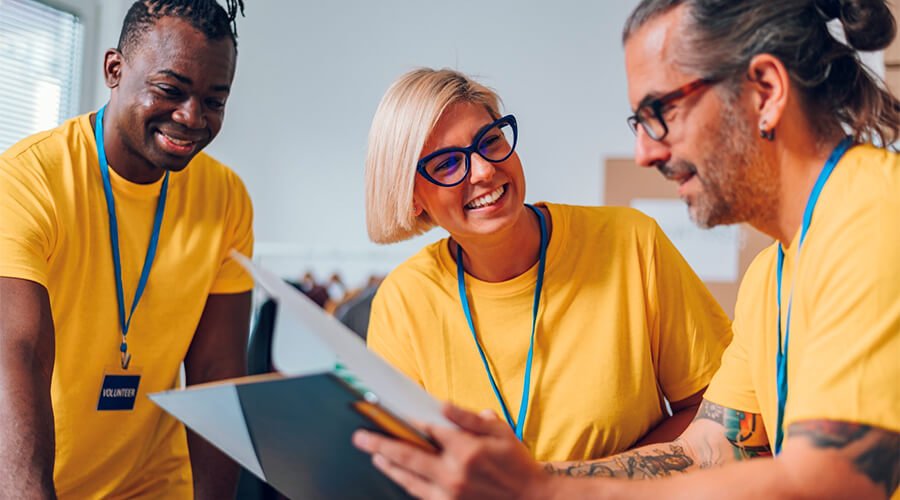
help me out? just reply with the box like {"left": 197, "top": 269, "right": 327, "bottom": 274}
{"left": 366, "top": 69, "right": 731, "bottom": 461}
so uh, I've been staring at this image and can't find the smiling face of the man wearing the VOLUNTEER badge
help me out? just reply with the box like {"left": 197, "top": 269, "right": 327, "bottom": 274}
{"left": 104, "top": 17, "right": 235, "bottom": 182}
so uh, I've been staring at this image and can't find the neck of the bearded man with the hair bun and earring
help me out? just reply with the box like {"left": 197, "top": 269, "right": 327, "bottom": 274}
{"left": 753, "top": 136, "right": 843, "bottom": 248}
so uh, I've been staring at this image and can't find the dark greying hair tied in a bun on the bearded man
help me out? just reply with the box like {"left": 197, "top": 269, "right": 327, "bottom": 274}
{"left": 622, "top": 0, "right": 900, "bottom": 146}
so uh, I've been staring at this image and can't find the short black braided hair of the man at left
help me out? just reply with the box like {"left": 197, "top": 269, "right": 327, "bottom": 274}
{"left": 118, "top": 0, "right": 244, "bottom": 53}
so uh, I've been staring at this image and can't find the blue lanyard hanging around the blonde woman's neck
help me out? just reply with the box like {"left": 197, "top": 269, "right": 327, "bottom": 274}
{"left": 456, "top": 204, "right": 548, "bottom": 441}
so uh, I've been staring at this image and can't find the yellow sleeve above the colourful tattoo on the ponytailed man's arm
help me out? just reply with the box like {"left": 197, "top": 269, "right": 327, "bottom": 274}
{"left": 703, "top": 286, "right": 762, "bottom": 414}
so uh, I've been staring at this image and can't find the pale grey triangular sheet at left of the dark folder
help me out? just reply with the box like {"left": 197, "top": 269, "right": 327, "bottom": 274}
{"left": 149, "top": 383, "right": 266, "bottom": 481}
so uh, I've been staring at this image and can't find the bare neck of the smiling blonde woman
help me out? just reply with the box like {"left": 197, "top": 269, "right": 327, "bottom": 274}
{"left": 449, "top": 206, "right": 550, "bottom": 283}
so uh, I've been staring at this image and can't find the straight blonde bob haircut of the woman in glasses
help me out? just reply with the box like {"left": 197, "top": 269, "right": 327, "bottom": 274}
{"left": 366, "top": 68, "right": 500, "bottom": 243}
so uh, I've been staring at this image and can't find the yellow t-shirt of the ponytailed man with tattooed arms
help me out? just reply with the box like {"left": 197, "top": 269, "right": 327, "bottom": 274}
{"left": 706, "top": 145, "right": 900, "bottom": 446}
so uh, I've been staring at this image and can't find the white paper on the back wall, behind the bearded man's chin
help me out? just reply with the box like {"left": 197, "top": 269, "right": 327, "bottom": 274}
{"left": 631, "top": 198, "right": 741, "bottom": 282}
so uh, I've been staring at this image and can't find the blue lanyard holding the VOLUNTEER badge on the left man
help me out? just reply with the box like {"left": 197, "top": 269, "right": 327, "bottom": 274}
{"left": 94, "top": 106, "right": 169, "bottom": 370}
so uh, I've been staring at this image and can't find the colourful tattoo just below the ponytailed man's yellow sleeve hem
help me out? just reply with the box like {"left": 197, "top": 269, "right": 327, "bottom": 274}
{"left": 694, "top": 400, "right": 772, "bottom": 460}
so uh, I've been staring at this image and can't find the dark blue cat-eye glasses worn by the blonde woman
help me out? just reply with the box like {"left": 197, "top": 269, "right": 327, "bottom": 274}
{"left": 416, "top": 115, "right": 518, "bottom": 187}
